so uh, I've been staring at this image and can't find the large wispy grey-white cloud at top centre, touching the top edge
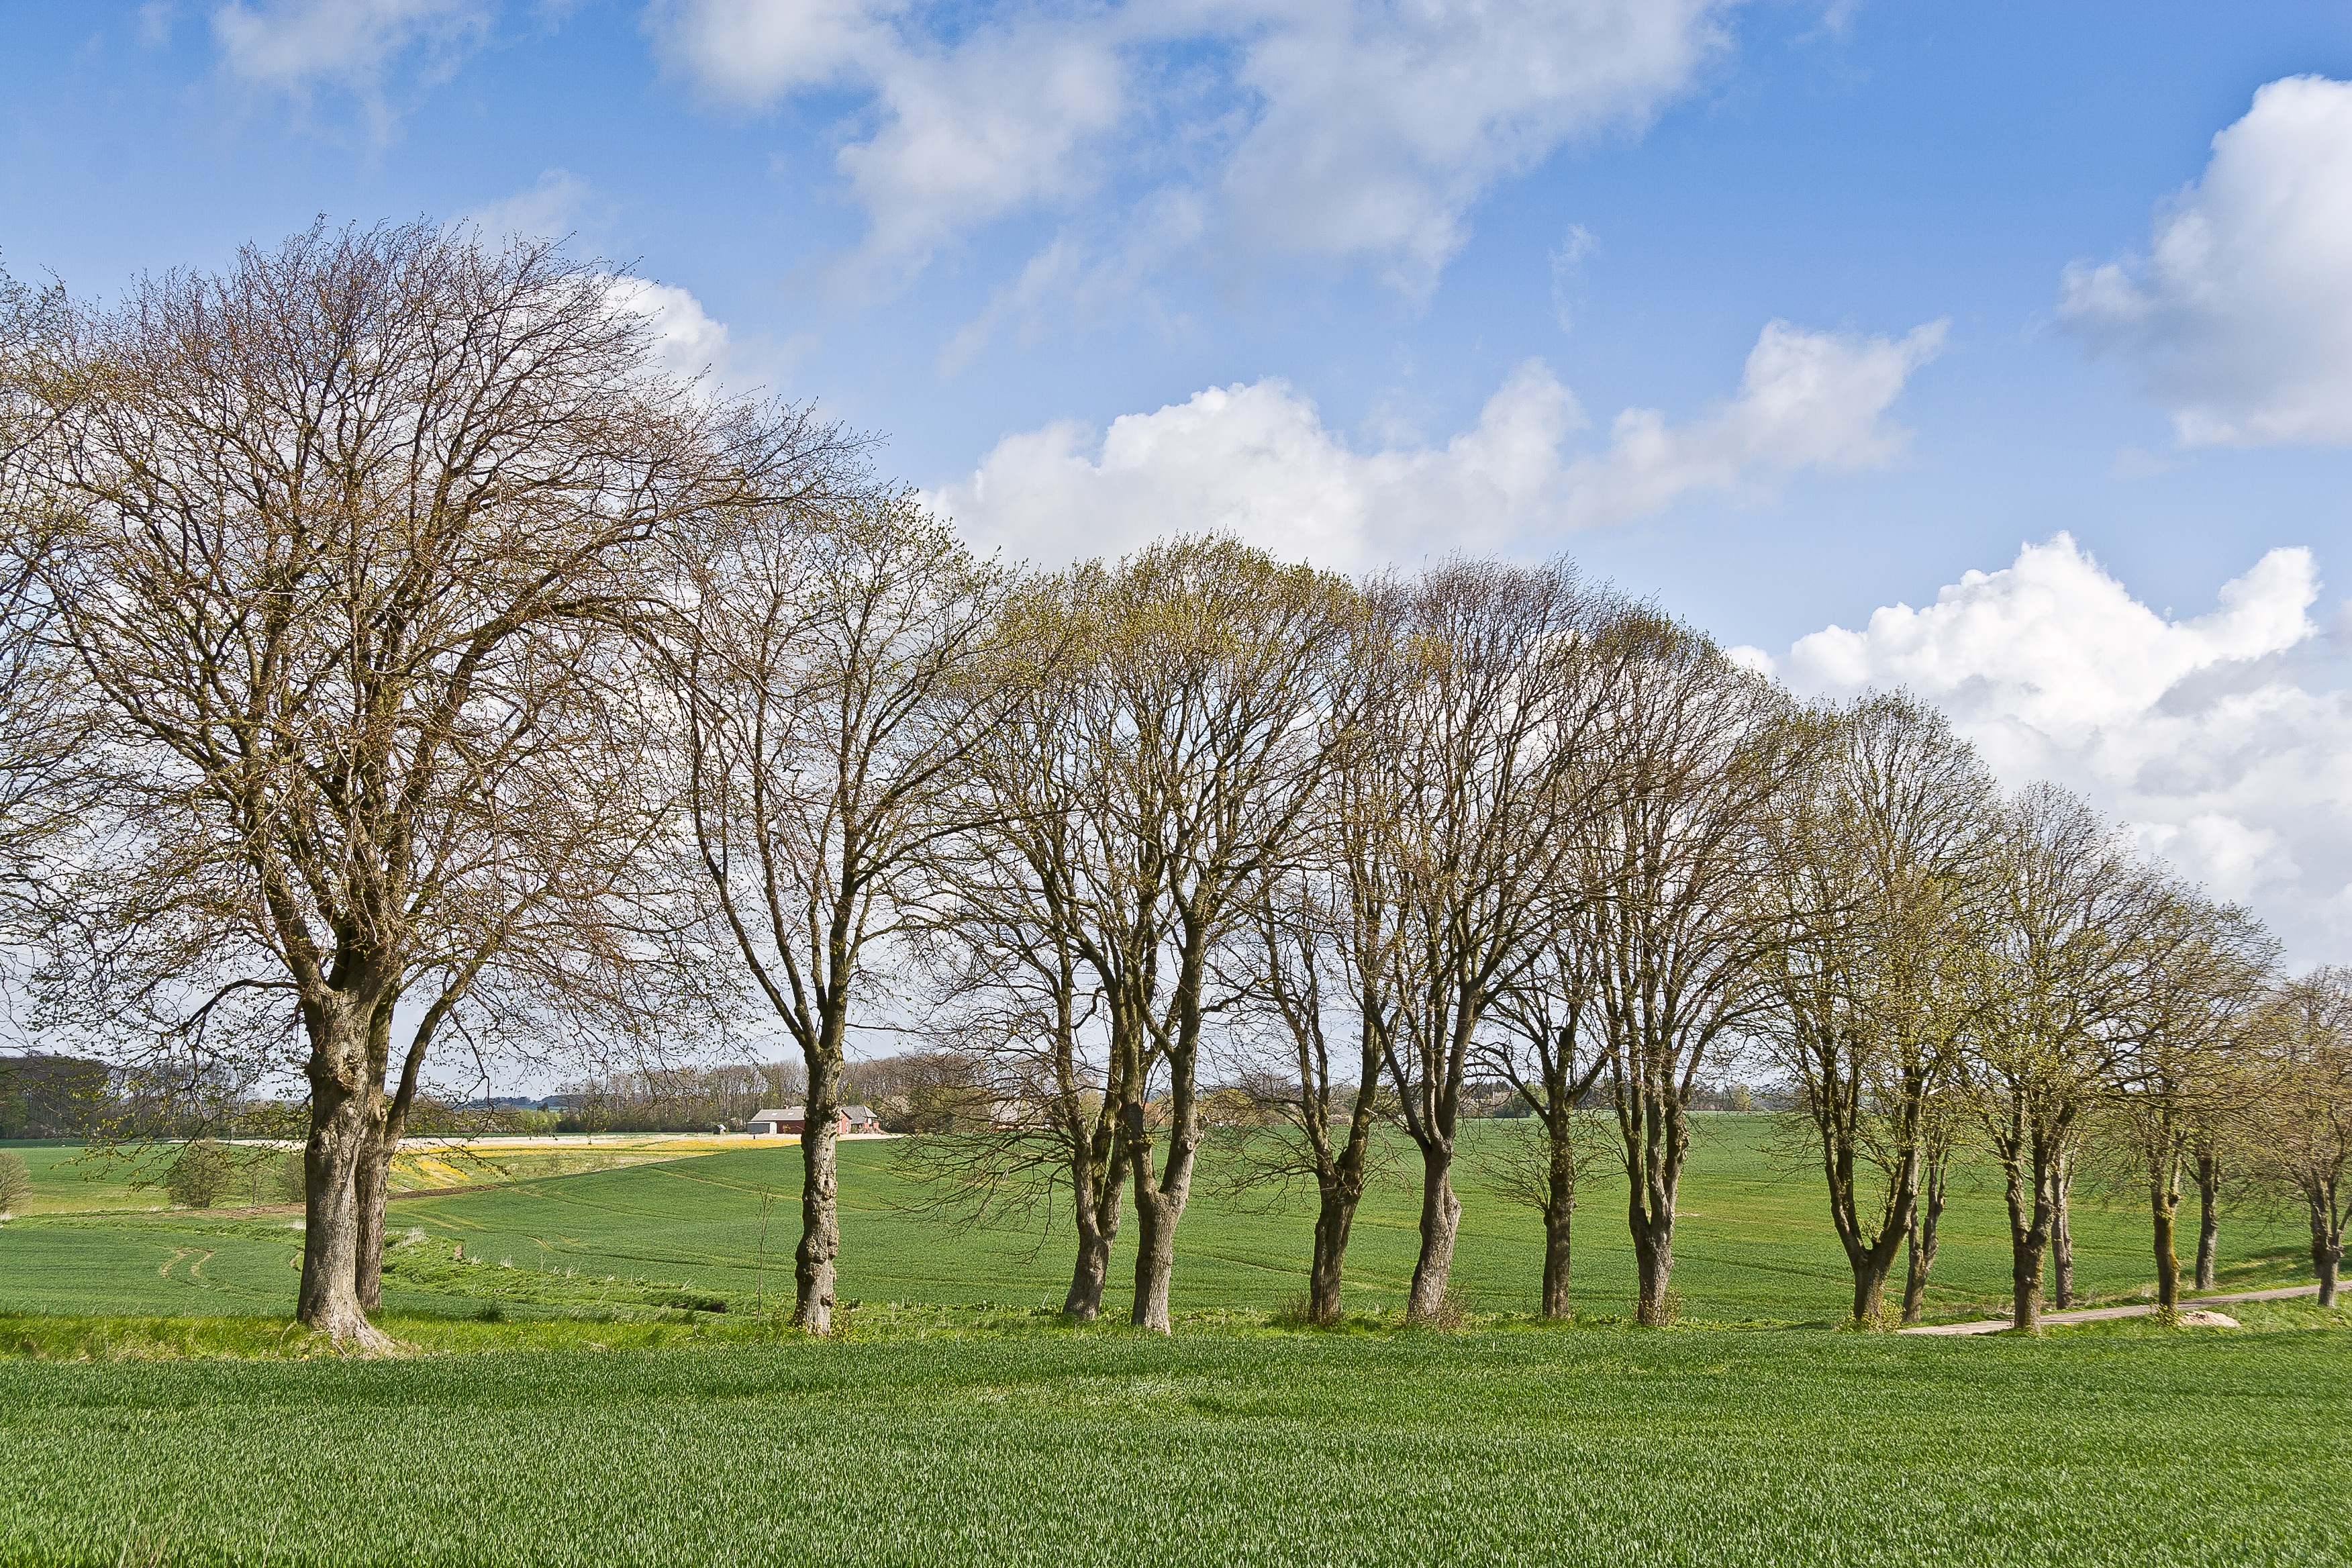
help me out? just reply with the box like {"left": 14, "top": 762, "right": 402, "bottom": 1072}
{"left": 649, "top": 0, "right": 1726, "bottom": 291}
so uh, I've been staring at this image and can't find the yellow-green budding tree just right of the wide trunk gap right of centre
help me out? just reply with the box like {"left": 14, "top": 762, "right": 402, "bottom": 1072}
{"left": 1759, "top": 696, "right": 1999, "bottom": 1328}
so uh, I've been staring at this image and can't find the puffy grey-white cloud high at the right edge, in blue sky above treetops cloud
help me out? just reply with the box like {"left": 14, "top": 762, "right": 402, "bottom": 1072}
{"left": 2058, "top": 75, "right": 2352, "bottom": 446}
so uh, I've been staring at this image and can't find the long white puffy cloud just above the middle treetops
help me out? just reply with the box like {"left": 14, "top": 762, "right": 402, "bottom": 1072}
{"left": 934, "top": 322, "right": 1943, "bottom": 567}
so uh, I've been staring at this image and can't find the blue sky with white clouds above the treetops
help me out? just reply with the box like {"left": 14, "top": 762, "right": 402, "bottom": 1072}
{"left": 0, "top": 0, "right": 2352, "bottom": 961}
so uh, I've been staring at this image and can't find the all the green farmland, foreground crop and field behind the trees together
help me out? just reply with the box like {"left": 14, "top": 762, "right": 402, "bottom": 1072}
{"left": 0, "top": 1117, "right": 2352, "bottom": 1565}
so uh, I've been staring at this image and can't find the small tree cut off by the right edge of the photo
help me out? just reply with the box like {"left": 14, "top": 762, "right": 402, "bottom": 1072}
{"left": 2249, "top": 969, "right": 2352, "bottom": 1307}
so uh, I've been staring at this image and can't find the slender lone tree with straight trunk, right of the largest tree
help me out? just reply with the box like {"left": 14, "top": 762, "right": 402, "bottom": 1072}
{"left": 671, "top": 493, "right": 1018, "bottom": 1335}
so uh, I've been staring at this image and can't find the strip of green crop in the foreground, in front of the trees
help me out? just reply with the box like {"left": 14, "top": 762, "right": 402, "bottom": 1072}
{"left": 0, "top": 1326, "right": 2352, "bottom": 1565}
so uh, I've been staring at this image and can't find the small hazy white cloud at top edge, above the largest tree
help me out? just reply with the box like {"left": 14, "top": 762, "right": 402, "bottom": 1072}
{"left": 211, "top": 0, "right": 494, "bottom": 111}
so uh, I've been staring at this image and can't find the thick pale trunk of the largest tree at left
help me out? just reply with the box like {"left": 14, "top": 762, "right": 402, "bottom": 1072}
{"left": 294, "top": 994, "right": 388, "bottom": 1349}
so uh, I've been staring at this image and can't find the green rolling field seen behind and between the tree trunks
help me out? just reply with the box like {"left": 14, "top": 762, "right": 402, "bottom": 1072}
{"left": 0, "top": 1117, "right": 2310, "bottom": 1321}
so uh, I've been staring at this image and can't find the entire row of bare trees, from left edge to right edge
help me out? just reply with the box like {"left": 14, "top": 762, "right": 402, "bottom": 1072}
{"left": 0, "top": 226, "right": 2345, "bottom": 1340}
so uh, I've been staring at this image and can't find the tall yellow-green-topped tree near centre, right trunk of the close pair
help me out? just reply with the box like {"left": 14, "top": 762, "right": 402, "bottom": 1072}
{"left": 1070, "top": 538, "right": 1359, "bottom": 1333}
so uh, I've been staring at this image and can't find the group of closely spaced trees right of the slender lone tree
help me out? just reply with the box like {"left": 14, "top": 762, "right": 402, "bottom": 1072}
{"left": 905, "top": 611, "right": 2352, "bottom": 1326}
